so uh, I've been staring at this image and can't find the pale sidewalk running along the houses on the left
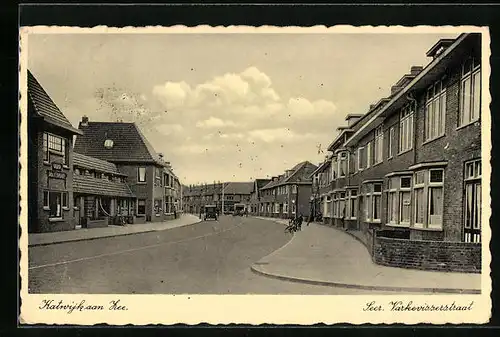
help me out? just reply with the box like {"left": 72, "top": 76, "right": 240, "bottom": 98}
{"left": 28, "top": 214, "right": 201, "bottom": 247}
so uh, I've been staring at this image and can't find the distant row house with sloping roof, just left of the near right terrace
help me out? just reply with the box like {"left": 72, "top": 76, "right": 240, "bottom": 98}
{"left": 258, "top": 161, "right": 317, "bottom": 219}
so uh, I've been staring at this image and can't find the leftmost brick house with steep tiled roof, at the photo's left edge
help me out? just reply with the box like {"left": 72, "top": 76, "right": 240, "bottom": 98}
{"left": 27, "top": 71, "right": 81, "bottom": 233}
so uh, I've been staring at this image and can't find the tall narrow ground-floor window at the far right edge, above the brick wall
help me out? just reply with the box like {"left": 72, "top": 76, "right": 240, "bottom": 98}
{"left": 464, "top": 159, "right": 481, "bottom": 242}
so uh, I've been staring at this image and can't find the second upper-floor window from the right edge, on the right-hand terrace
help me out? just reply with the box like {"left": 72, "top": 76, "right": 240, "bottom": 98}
{"left": 424, "top": 81, "right": 446, "bottom": 141}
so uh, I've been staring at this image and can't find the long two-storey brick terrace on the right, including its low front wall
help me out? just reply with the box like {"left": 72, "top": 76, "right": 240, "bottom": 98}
{"left": 316, "top": 34, "right": 489, "bottom": 272}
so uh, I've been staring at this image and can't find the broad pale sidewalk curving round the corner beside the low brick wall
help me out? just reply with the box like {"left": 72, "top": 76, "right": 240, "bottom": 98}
{"left": 251, "top": 218, "right": 481, "bottom": 294}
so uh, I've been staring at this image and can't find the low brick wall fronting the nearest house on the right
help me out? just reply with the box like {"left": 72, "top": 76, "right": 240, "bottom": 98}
{"left": 373, "top": 236, "right": 481, "bottom": 273}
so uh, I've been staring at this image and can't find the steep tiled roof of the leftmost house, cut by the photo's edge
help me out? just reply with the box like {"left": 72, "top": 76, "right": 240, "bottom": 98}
{"left": 28, "top": 70, "right": 81, "bottom": 134}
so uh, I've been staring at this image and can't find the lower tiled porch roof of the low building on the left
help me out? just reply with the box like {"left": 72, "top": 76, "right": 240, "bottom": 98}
{"left": 73, "top": 174, "right": 135, "bottom": 198}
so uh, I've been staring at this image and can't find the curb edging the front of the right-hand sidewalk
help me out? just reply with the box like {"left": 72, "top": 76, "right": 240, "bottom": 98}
{"left": 250, "top": 265, "right": 481, "bottom": 295}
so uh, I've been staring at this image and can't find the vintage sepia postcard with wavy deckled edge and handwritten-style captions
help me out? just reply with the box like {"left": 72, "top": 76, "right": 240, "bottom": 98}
{"left": 19, "top": 26, "right": 491, "bottom": 325}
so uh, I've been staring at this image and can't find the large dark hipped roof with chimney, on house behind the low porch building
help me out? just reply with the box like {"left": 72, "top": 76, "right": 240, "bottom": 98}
{"left": 74, "top": 122, "right": 166, "bottom": 166}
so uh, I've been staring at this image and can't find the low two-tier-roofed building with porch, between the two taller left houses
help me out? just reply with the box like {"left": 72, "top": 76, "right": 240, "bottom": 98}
{"left": 73, "top": 152, "right": 137, "bottom": 228}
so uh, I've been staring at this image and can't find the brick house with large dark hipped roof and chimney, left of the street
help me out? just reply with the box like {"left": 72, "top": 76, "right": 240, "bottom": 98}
{"left": 75, "top": 116, "right": 180, "bottom": 223}
